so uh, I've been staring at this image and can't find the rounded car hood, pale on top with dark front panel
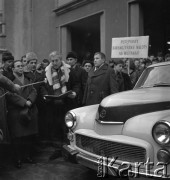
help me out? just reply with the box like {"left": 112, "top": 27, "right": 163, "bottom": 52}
{"left": 98, "top": 87, "right": 170, "bottom": 122}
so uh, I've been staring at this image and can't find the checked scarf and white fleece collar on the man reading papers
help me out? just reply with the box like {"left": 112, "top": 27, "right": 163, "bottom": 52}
{"left": 45, "top": 61, "right": 70, "bottom": 95}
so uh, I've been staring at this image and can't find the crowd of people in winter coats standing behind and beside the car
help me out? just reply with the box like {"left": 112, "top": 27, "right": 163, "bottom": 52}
{"left": 0, "top": 51, "right": 170, "bottom": 168}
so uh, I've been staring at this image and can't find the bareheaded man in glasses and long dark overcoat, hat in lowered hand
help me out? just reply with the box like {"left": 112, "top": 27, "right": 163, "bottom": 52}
{"left": 7, "top": 60, "right": 38, "bottom": 168}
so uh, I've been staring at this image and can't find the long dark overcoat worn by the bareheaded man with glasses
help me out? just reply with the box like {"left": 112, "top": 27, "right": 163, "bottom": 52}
{"left": 7, "top": 75, "right": 38, "bottom": 138}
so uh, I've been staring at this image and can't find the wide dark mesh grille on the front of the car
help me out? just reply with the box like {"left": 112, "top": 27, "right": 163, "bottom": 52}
{"left": 76, "top": 134, "right": 146, "bottom": 162}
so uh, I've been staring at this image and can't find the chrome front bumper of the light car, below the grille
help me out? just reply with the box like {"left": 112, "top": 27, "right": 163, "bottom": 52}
{"left": 63, "top": 145, "right": 169, "bottom": 179}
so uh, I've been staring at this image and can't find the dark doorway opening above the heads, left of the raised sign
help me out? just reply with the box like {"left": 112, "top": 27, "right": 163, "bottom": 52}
{"left": 68, "top": 15, "right": 100, "bottom": 63}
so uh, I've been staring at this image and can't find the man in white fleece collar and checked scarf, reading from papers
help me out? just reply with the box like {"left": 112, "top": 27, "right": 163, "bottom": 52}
{"left": 45, "top": 51, "right": 70, "bottom": 150}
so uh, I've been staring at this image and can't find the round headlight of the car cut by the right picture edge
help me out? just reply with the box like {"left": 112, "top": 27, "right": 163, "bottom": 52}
{"left": 152, "top": 120, "right": 170, "bottom": 145}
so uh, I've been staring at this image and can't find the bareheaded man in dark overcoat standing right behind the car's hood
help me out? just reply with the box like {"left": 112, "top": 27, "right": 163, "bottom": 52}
{"left": 83, "top": 52, "right": 118, "bottom": 105}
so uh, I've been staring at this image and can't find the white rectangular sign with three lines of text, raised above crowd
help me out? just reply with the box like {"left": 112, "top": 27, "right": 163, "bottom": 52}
{"left": 111, "top": 36, "right": 149, "bottom": 58}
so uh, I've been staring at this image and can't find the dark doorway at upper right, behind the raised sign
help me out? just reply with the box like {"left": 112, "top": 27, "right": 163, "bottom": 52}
{"left": 140, "top": 0, "right": 170, "bottom": 55}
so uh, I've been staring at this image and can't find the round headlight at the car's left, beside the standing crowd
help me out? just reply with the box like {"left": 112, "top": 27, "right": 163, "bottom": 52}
{"left": 65, "top": 112, "right": 76, "bottom": 129}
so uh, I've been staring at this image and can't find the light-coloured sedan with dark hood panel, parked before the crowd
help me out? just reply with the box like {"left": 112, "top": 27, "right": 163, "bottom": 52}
{"left": 64, "top": 62, "right": 170, "bottom": 179}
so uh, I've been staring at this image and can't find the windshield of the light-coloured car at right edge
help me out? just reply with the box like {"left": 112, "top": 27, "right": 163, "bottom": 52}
{"left": 134, "top": 65, "right": 170, "bottom": 89}
